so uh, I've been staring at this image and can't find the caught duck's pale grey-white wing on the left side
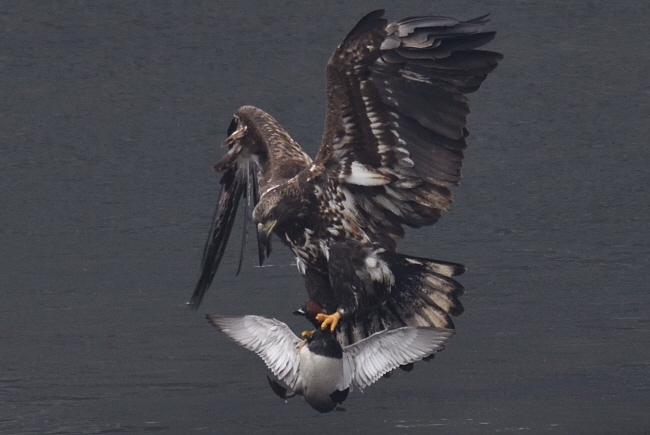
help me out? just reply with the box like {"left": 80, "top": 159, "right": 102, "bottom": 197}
{"left": 206, "top": 314, "right": 301, "bottom": 390}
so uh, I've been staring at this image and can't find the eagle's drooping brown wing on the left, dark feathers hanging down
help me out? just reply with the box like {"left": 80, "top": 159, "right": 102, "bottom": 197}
{"left": 190, "top": 106, "right": 311, "bottom": 309}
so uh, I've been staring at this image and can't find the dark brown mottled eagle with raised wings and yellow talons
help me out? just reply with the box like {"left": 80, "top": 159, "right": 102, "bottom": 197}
{"left": 189, "top": 10, "right": 502, "bottom": 346}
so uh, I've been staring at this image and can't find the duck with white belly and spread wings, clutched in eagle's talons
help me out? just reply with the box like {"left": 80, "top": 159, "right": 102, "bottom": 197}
{"left": 206, "top": 314, "right": 455, "bottom": 413}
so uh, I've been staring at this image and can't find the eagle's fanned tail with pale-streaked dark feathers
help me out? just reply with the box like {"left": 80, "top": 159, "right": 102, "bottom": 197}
{"left": 383, "top": 253, "right": 465, "bottom": 329}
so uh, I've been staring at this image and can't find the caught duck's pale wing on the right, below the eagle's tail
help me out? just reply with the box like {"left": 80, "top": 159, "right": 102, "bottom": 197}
{"left": 343, "top": 327, "right": 454, "bottom": 389}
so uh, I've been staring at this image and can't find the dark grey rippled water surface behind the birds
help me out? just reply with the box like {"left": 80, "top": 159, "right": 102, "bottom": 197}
{"left": 0, "top": 0, "right": 650, "bottom": 434}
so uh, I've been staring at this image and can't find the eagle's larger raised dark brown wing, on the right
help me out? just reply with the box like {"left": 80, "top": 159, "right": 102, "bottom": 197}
{"left": 314, "top": 10, "right": 502, "bottom": 247}
